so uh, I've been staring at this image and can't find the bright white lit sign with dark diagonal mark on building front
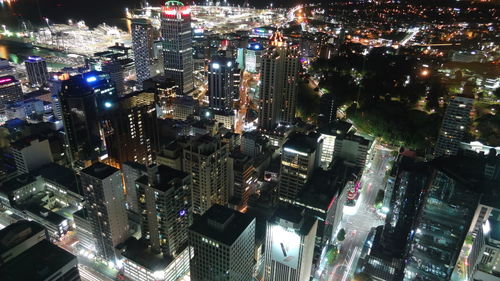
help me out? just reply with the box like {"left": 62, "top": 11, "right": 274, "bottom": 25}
{"left": 271, "top": 225, "right": 300, "bottom": 269}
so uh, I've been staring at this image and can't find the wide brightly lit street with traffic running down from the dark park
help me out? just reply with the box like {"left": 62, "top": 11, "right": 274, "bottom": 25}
{"left": 319, "top": 145, "right": 391, "bottom": 281}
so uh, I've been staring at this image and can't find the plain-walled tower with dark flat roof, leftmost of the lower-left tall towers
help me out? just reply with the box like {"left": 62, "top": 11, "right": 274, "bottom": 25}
{"left": 80, "top": 162, "right": 129, "bottom": 262}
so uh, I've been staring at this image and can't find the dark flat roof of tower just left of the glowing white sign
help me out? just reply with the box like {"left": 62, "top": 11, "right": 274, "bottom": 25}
{"left": 189, "top": 204, "right": 255, "bottom": 245}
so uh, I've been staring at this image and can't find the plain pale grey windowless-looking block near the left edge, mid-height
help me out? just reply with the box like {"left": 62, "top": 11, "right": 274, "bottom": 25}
{"left": 10, "top": 138, "right": 53, "bottom": 174}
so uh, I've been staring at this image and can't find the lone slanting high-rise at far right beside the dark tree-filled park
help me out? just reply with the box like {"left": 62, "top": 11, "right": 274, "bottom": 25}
{"left": 434, "top": 95, "right": 474, "bottom": 157}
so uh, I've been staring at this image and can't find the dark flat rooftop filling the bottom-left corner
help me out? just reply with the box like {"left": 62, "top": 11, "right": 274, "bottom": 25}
{"left": 0, "top": 240, "right": 77, "bottom": 281}
